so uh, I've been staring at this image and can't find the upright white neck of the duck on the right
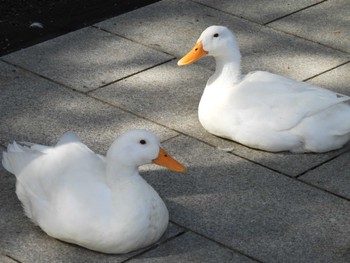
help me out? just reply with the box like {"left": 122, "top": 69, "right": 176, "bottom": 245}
{"left": 208, "top": 51, "right": 241, "bottom": 87}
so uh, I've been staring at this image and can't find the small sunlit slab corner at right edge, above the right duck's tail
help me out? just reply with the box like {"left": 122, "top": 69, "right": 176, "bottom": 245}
{"left": 307, "top": 63, "right": 350, "bottom": 96}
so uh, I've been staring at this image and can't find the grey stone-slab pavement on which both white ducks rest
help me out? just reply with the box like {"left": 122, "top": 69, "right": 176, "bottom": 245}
{"left": 0, "top": 0, "right": 350, "bottom": 263}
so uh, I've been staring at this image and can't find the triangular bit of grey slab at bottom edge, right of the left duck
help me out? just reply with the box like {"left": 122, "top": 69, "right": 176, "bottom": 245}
{"left": 130, "top": 232, "right": 256, "bottom": 263}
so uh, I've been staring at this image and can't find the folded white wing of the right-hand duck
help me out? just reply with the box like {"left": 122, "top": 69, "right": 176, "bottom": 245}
{"left": 239, "top": 71, "right": 350, "bottom": 131}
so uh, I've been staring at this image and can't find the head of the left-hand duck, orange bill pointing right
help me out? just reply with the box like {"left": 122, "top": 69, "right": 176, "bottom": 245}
{"left": 107, "top": 130, "right": 186, "bottom": 172}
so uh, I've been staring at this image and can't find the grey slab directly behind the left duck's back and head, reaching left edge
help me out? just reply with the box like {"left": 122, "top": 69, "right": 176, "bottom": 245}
{"left": 0, "top": 62, "right": 177, "bottom": 154}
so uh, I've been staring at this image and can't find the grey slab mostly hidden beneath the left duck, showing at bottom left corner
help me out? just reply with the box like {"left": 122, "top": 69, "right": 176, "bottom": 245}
{"left": 0, "top": 146, "right": 184, "bottom": 263}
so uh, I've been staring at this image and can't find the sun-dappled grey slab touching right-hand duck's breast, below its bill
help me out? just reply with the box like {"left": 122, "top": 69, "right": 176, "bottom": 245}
{"left": 89, "top": 61, "right": 208, "bottom": 138}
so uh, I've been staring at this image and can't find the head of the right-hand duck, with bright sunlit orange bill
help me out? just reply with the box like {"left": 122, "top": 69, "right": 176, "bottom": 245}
{"left": 177, "top": 26, "right": 240, "bottom": 66}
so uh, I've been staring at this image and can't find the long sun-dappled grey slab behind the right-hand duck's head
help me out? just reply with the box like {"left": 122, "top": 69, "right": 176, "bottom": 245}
{"left": 96, "top": 0, "right": 350, "bottom": 80}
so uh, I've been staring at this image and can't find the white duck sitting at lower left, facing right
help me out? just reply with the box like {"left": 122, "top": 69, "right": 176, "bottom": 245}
{"left": 2, "top": 130, "right": 185, "bottom": 253}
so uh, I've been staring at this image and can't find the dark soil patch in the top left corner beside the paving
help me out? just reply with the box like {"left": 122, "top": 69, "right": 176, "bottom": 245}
{"left": 0, "top": 0, "right": 158, "bottom": 56}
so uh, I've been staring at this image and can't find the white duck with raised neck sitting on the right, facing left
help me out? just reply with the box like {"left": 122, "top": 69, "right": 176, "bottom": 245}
{"left": 178, "top": 26, "right": 350, "bottom": 152}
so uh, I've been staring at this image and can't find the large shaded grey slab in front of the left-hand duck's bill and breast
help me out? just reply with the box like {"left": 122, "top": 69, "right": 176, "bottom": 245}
{"left": 144, "top": 136, "right": 350, "bottom": 263}
